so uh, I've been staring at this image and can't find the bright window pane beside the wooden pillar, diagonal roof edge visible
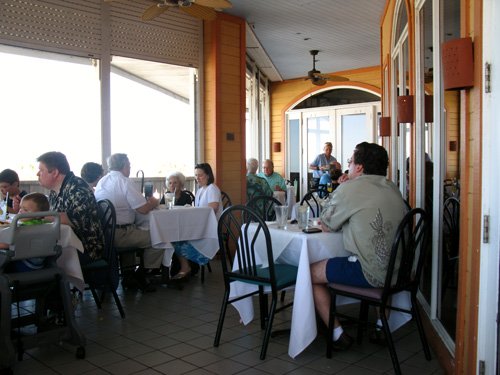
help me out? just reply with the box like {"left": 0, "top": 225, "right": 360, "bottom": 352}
{"left": 111, "top": 57, "right": 195, "bottom": 177}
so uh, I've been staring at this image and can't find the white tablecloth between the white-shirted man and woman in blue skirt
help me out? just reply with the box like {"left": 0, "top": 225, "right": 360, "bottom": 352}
{"left": 149, "top": 206, "right": 219, "bottom": 265}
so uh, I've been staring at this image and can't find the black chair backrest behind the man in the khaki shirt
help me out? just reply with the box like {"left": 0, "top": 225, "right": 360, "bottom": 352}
{"left": 384, "top": 208, "right": 429, "bottom": 297}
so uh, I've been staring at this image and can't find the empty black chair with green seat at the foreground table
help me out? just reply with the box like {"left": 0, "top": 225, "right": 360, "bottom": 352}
{"left": 214, "top": 205, "right": 297, "bottom": 359}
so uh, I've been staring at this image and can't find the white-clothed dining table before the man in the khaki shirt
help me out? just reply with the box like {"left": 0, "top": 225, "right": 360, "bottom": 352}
{"left": 230, "top": 222, "right": 411, "bottom": 358}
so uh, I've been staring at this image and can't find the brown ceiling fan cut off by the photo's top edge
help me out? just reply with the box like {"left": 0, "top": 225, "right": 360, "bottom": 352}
{"left": 104, "top": 0, "right": 233, "bottom": 21}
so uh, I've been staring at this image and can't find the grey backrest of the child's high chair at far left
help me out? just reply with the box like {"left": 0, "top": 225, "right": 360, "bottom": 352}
{"left": 2, "top": 211, "right": 61, "bottom": 261}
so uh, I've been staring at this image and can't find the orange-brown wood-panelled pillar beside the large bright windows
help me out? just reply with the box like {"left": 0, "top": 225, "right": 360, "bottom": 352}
{"left": 203, "top": 14, "right": 246, "bottom": 203}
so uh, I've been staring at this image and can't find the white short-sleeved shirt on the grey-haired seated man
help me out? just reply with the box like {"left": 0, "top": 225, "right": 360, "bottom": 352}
{"left": 95, "top": 171, "right": 146, "bottom": 225}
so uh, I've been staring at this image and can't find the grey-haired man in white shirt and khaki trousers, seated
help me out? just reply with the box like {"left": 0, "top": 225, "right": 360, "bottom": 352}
{"left": 95, "top": 154, "right": 164, "bottom": 292}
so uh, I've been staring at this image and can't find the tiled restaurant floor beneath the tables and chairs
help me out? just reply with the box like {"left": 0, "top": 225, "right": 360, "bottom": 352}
{"left": 10, "top": 262, "right": 443, "bottom": 375}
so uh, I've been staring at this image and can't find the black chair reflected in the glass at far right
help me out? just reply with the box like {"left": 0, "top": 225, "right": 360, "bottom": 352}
{"left": 441, "top": 197, "right": 460, "bottom": 300}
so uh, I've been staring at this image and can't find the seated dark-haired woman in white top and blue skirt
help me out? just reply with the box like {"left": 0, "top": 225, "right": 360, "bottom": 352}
{"left": 172, "top": 163, "right": 222, "bottom": 280}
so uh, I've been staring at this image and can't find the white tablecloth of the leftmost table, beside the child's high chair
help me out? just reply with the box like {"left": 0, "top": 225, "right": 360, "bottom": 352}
{"left": 0, "top": 224, "right": 85, "bottom": 291}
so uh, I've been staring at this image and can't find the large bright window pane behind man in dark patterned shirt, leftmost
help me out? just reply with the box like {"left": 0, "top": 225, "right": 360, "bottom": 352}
{"left": 0, "top": 46, "right": 101, "bottom": 180}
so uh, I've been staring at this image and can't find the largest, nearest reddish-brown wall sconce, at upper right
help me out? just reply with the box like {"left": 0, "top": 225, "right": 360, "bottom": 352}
{"left": 441, "top": 38, "right": 474, "bottom": 90}
